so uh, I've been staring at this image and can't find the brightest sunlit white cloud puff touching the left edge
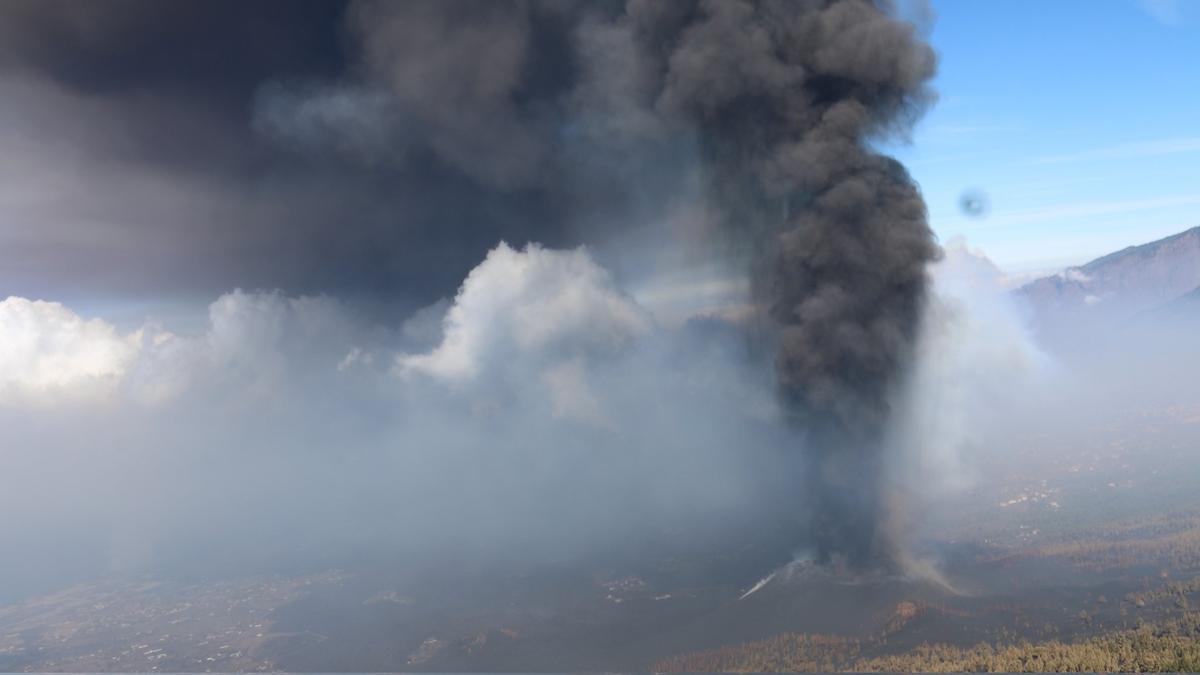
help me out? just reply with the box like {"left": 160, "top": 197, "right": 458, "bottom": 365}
{"left": 0, "top": 297, "right": 142, "bottom": 404}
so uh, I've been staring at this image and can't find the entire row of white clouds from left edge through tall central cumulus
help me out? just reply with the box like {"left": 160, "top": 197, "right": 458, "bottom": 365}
{"left": 0, "top": 244, "right": 652, "bottom": 410}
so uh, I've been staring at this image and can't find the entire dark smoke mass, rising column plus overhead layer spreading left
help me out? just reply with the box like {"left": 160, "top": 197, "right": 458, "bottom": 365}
{"left": 0, "top": 0, "right": 937, "bottom": 567}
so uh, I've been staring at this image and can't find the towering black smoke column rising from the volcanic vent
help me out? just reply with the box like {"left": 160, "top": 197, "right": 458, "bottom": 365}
{"left": 643, "top": 0, "right": 938, "bottom": 569}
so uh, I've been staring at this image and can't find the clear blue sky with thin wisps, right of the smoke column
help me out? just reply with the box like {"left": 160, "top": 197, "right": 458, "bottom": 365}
{"left": 888, "top": 0, "right": 1200, "bottom": 273}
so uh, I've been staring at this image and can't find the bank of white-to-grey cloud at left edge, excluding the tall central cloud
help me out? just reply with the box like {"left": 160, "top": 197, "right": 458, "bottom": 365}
{"left": 0, "top": 289, "right": 373, "bottom": 406}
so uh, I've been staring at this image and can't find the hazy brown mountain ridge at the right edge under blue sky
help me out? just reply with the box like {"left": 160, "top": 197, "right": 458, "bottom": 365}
{"left": 1019, "top": 227, "right": 1200, "bottom": 318}
